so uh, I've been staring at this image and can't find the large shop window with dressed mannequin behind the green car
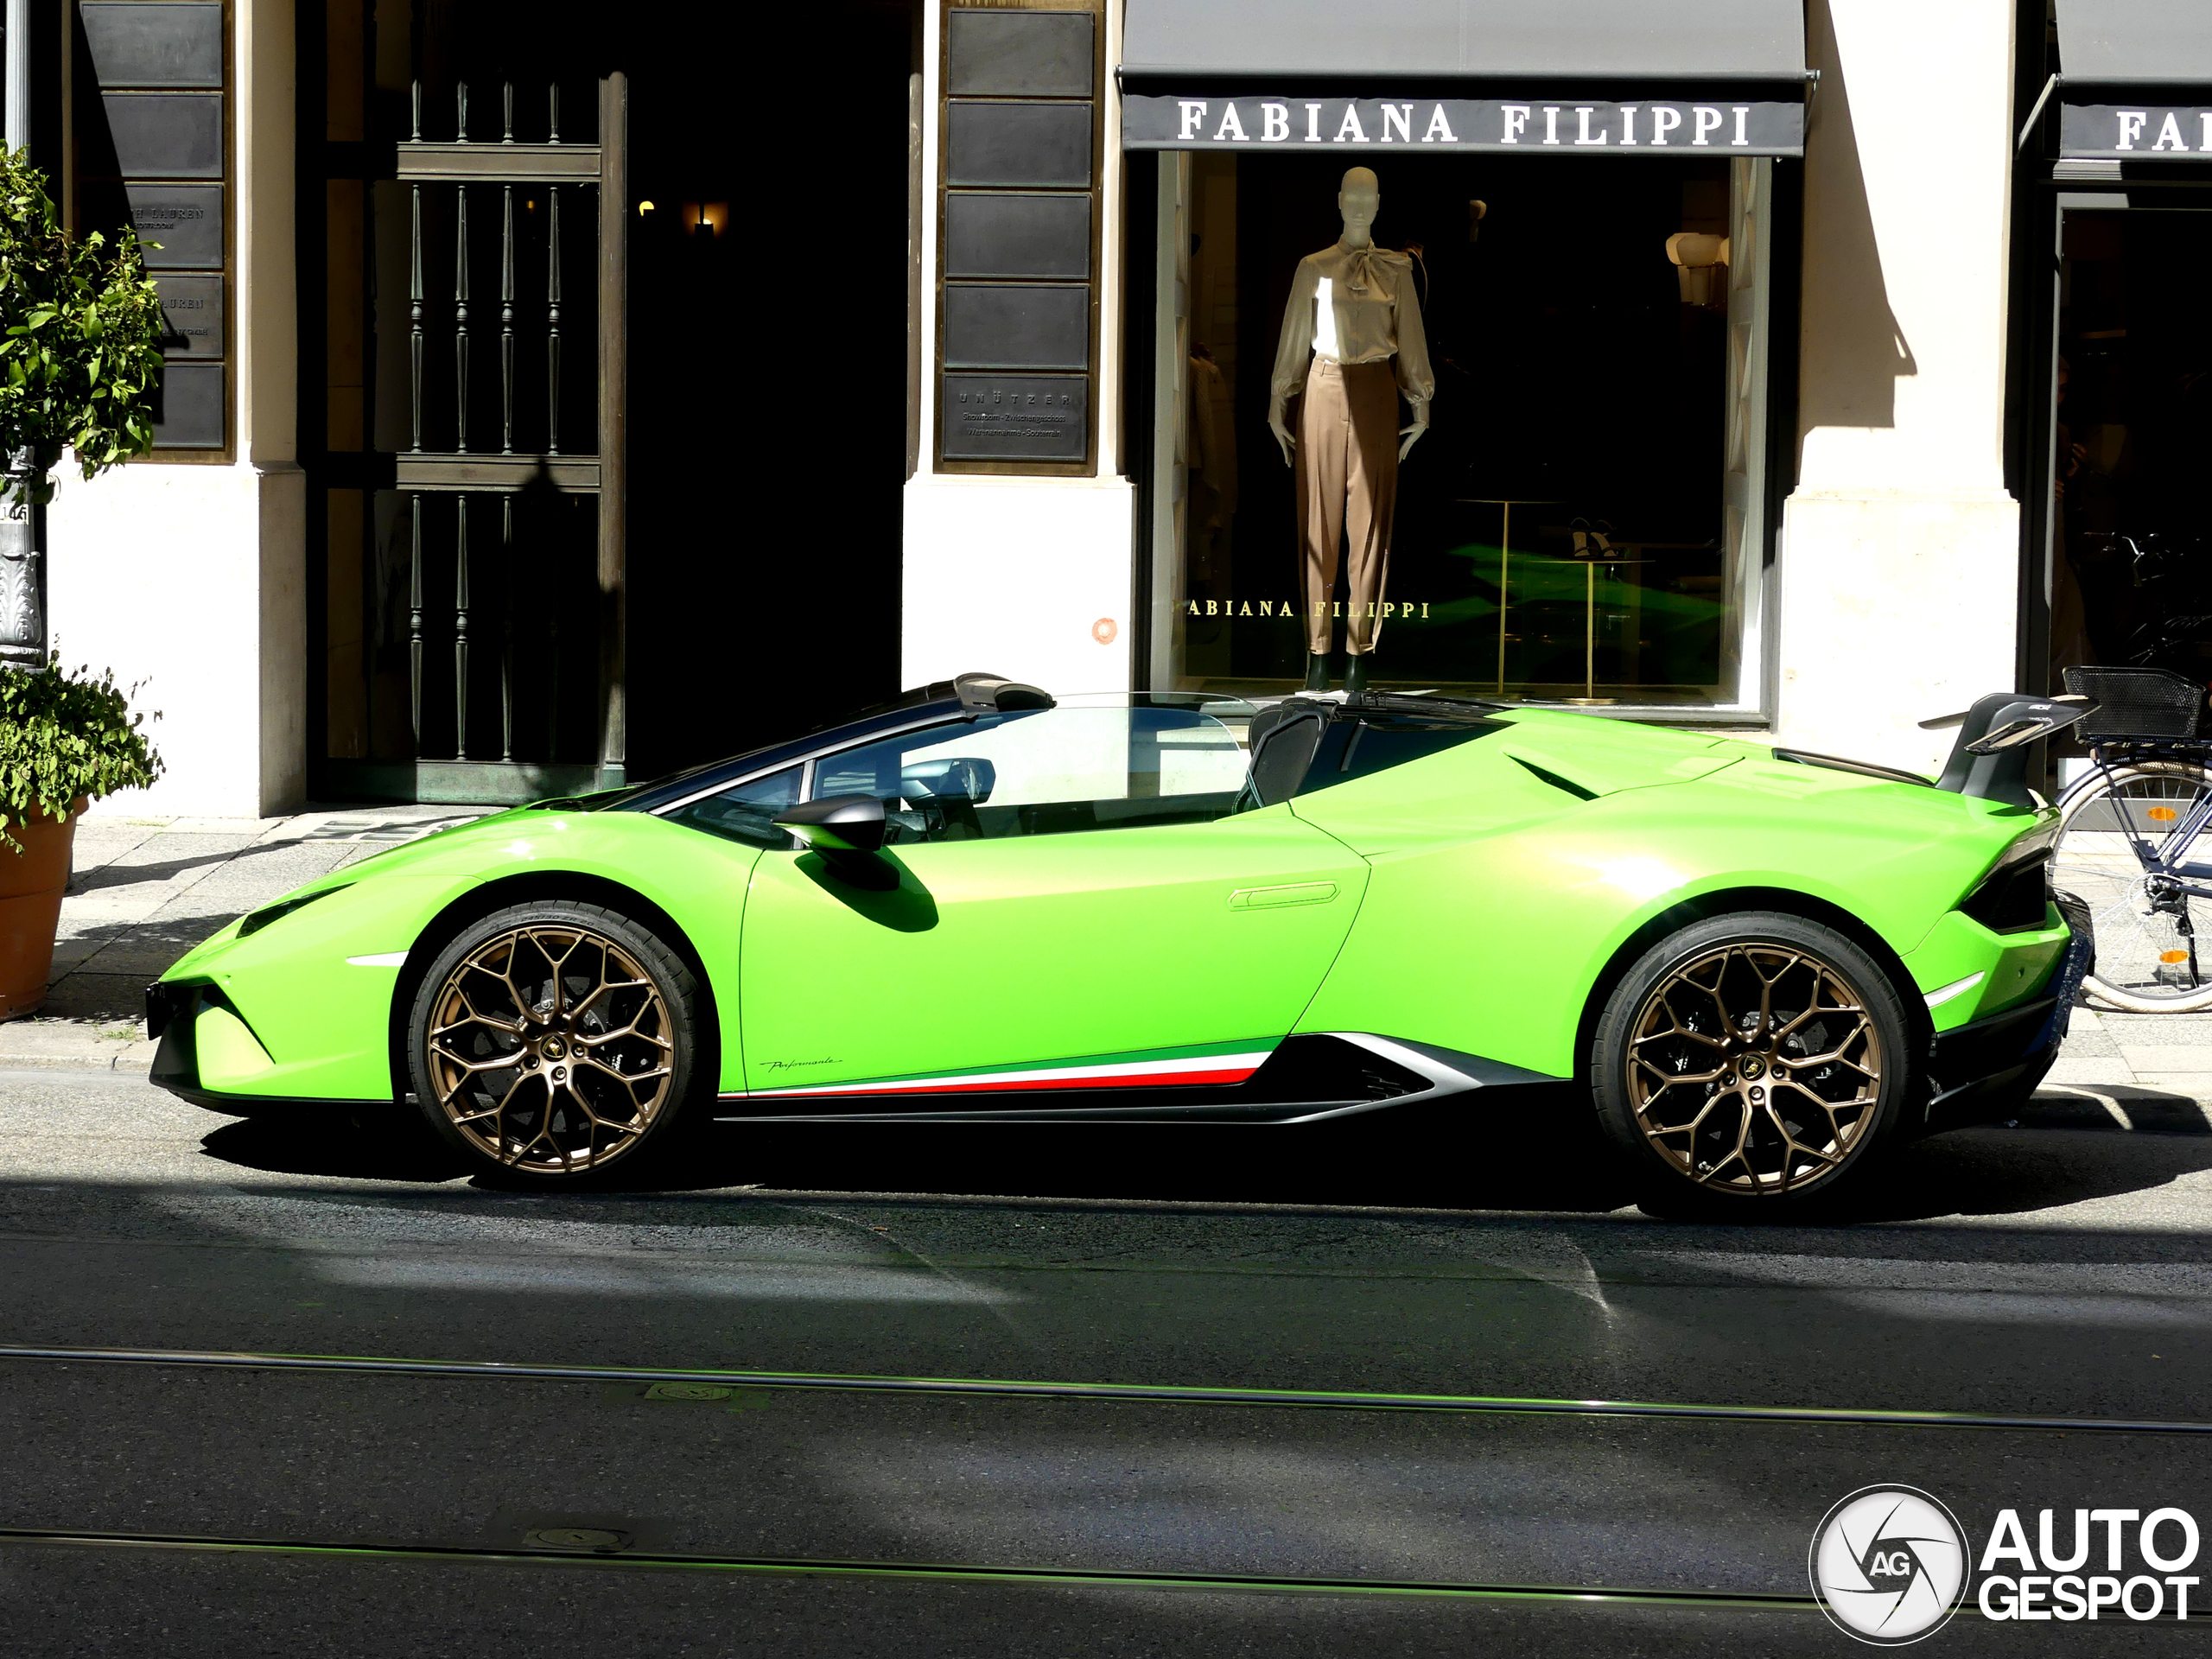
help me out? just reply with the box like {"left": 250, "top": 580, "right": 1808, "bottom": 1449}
{"left": 1150, "top": 153, "right": 1772, "bottom": 708}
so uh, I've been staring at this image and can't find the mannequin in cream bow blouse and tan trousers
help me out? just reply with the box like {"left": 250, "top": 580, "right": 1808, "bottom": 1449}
{"left": 1268, "top": 168, "right": 1435, "bottom": 690}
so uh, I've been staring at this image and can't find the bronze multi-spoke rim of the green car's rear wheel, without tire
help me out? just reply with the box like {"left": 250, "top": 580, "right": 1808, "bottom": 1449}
{"left": 1624, "top": 943, "right": 1883, "bottom": 1194}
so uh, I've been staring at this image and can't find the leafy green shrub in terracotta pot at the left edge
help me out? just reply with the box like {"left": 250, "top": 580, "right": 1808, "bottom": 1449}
{"left": 0, "top": 657, "right": 162, "bottom": 1020}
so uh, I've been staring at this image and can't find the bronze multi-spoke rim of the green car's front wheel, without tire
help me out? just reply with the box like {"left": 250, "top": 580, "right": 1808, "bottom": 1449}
{"left": 423, "top": 923, "right": 675, "bottom": 1177}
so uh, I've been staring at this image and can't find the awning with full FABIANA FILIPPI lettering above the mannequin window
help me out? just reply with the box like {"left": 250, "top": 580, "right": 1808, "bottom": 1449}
{"left": 1119, "top": 0, "right": 1809, "bottom": 155}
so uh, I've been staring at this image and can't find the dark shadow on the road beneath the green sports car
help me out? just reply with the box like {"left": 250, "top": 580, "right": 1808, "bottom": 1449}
{"left": 186, "top": 1084, "right": 2212, "bottom": 1225}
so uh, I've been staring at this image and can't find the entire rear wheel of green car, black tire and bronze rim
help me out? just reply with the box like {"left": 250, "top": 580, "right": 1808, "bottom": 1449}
{"left": 1591, "top": 912, "right": 1920, "bottom": 1219}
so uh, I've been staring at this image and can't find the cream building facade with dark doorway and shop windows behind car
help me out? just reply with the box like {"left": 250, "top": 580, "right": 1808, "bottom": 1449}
{"left": 30, "top": 0, "right": 2212, "bottom": 812}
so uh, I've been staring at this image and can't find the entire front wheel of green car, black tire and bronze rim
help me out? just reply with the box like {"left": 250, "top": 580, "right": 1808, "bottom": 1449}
{"left": 407, "top": 900, "right": 712, "bottom": 1185}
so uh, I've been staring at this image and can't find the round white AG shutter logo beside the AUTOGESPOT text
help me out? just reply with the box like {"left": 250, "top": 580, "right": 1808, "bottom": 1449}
{"left": 1808, "top": 1486, "right": 1967, "bottom": 1648}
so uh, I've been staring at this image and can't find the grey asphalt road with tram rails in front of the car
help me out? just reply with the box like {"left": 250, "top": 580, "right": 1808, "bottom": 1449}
{"left": 0, "top": 1073, "right": 2212, "bottom": 1656}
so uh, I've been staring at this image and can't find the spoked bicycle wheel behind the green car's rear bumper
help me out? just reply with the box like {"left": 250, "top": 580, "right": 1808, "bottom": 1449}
{"left": 2050, "top": 761, "right": 2212, "bottom": 1013}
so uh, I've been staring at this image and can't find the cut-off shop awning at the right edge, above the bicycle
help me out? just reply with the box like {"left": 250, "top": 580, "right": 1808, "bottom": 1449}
{"left": 2057, "top": 0, "right": 2212, "bottom": 162}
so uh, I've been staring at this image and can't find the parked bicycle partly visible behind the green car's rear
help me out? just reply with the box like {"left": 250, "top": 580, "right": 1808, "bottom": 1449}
{"left": 2050, "top": 668, "right": 2212, "bottom": 1013}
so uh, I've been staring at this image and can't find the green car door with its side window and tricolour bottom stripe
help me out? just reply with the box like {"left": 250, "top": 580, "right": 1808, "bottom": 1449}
{"left": 739, "top": 696, "right": 1367, "bottom": 1110}
